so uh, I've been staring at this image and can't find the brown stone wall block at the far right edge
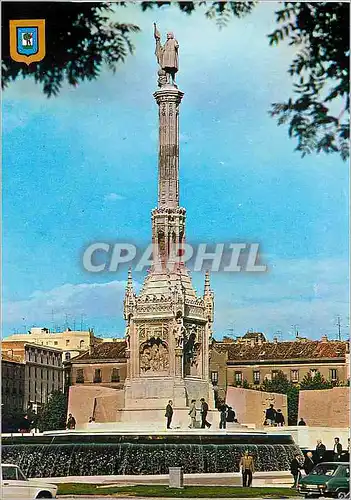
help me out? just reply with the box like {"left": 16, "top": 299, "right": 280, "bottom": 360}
{"left": 299, "top": 387, "right": 350, "bottom": 427}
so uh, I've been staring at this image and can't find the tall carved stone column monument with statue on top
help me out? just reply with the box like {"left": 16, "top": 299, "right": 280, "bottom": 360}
{"left": 122, "top": 25, "right": 214, "bottom": 425}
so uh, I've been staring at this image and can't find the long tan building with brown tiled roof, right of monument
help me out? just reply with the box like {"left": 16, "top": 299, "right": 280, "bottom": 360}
{"left": 210, "top": 334, "right": 350, "bottom": 400}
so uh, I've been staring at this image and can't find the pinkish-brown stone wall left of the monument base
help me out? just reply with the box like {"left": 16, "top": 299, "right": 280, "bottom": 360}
{"left": 68, "top": 384, "right": 124, "bottom": 428}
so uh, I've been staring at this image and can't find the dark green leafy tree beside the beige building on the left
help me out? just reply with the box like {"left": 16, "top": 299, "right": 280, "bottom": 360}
{"left": 39, "top": 391, "right": 67, "bottom": 431}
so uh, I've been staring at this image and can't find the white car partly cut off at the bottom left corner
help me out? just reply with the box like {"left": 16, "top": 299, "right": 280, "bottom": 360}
{"left": 0, "top": 464, "right": 57, "bottom": 500}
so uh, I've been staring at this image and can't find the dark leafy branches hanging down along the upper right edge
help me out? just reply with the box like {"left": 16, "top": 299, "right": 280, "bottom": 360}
{"left": 269, "top": 2, "right": 350, "bottom": 160}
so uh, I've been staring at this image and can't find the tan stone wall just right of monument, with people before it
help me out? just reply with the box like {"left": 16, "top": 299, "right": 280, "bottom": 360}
{"left": 226, "top": 387, "right": 288, "bottom": 427}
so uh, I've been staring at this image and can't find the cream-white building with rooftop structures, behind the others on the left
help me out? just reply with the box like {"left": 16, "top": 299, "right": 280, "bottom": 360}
{"left": 5, "top": 328, "right": 103, "bottom": 361}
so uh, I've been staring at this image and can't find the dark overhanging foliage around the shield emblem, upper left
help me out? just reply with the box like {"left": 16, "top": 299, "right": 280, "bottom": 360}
{"left": 2, "top": 2, "right": 139, "bottom": 97}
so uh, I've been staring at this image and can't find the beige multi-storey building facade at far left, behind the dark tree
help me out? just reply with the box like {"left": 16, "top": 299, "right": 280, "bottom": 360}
{"left": 1, "top": 340, "right": 64, "bottom": 411}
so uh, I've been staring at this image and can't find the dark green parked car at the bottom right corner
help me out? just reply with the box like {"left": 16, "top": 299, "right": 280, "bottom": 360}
{"left": 298, "top": 462, "right": 350, "bottom": 498}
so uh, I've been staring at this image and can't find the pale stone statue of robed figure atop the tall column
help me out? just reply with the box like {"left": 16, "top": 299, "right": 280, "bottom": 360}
{"left": 154, "top": 23, "right": 179, "bottom": 85}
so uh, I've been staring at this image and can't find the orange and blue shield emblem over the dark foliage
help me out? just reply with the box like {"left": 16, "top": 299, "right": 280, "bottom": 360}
{"left": 10, "top": 19, "right": 45, "bottom": 65}
